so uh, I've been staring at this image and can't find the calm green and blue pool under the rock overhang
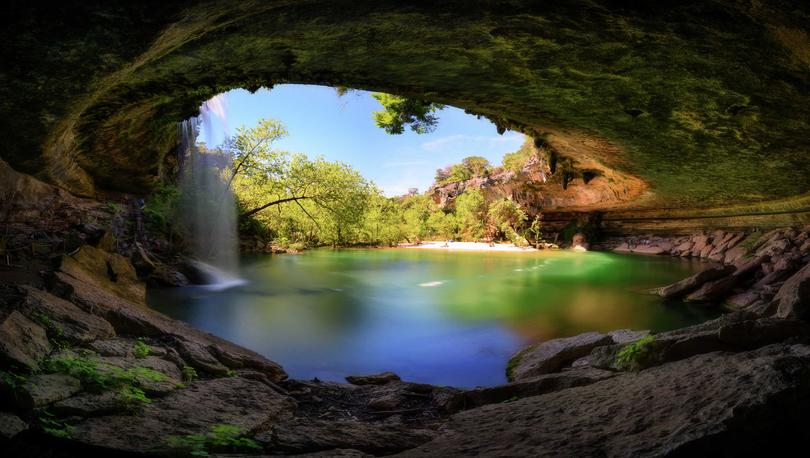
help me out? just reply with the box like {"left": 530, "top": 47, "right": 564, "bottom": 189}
{"left": 148, "top": 249, "right": 710, "bottom": 387}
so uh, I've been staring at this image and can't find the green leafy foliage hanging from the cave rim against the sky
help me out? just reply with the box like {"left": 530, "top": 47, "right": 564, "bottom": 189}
{"left": 371, "top": 92, "right": 444, "bottom": 135}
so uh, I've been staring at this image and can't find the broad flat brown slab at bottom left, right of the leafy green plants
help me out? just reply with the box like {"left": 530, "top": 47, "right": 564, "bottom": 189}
{"left": 73, "top": 377, "right": 295, "bottom": 453}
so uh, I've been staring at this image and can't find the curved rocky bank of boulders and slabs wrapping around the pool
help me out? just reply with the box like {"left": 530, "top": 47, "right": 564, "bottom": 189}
{"left": 0, "top": 165, "right": 810, "bottom": 457}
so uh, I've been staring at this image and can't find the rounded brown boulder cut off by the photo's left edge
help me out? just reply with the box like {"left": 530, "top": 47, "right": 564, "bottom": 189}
{"left": 0, "top": 310, "right": 51, "bottom": 368}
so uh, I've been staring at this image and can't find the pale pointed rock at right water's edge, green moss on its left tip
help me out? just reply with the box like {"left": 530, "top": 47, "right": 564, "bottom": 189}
{"left": 507, "top": 332, "right": 613, "bottom": 382}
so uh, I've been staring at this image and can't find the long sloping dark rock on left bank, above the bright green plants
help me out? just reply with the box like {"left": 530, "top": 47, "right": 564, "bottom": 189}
{"left": 22, "top": 286, "right": 115, "bottom": 344}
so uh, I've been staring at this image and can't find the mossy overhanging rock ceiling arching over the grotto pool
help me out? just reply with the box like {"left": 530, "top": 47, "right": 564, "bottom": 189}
{"left": 0, "top": 0, "right": 810, "bottom": 220}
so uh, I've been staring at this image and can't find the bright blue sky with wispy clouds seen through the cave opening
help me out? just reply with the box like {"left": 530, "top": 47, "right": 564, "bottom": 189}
{"left": 199, "top": 85, "right": 523, "bottom": 196}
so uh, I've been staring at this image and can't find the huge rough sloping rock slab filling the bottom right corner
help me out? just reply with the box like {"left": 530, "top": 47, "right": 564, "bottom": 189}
{"left": 399, "top": 345, "right": 810, "bottom": 457}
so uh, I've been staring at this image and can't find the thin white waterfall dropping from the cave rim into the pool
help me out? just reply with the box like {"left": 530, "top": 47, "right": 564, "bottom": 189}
{"left": 177, "top": 96, "right": 244, "bottom": 290}
